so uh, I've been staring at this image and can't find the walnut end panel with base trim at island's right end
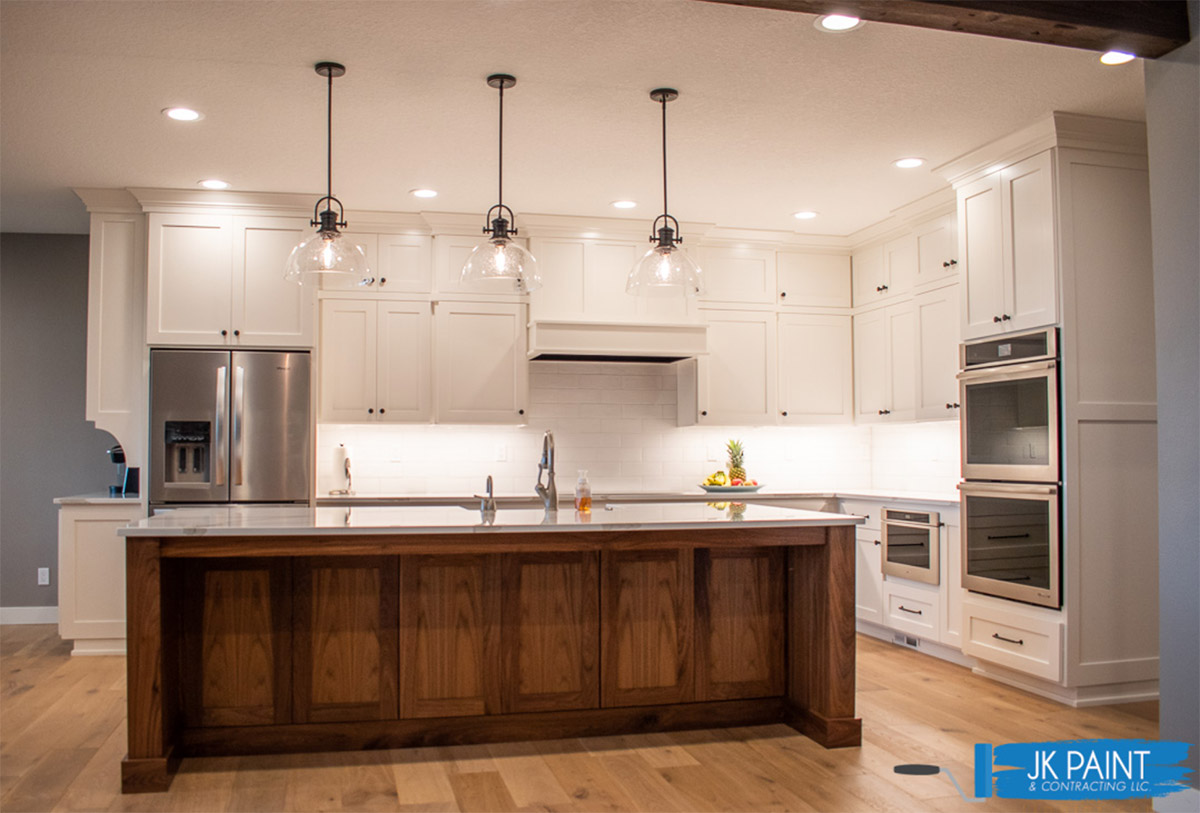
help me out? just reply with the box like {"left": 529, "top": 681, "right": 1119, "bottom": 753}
{"left": 787, "top": 525, "right": 863, "bottom": 748}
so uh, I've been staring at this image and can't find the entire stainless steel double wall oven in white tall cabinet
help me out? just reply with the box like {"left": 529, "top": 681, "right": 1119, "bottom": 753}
{"left": 959, "top": 327, "right": 1062, "bottom": 608}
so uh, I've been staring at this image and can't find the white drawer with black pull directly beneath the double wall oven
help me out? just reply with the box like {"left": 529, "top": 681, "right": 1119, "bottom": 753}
{"left": 962, "top": 604, "right": 1062, "bottom": 682}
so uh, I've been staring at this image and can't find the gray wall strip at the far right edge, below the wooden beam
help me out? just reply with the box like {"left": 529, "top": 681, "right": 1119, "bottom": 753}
{"left": 1145, "top": 0, "right": 1200, "bottom": 796}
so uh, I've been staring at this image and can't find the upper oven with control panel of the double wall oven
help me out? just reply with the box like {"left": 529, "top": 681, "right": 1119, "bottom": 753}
{"left": 959, "top": 327, "right": 1060, "bottom": 483}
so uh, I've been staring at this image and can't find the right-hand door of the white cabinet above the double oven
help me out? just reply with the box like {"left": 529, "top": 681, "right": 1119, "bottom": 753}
{"left": 1000, "top": 150, "right": 1058, "bottom": 331}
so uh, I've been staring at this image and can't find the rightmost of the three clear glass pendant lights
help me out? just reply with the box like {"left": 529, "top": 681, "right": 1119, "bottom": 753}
{"left": 625, "top": 88, "right": 704, "bottom": 296}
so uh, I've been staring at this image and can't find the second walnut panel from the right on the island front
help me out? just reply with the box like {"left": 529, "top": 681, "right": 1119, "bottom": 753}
{"left": 600, "top": 549, "right": 696, "bottom": 707}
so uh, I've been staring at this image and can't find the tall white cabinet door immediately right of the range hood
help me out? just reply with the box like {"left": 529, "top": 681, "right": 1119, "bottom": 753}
{"left": 697, "top": 308, "right": 776, "bottom": 426}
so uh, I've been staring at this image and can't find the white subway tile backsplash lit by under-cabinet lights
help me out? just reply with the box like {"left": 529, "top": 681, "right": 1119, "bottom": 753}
{"left": 317, "top": 361, "right": 959, "bottom": 495}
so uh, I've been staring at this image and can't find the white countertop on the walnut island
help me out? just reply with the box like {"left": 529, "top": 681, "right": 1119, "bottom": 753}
{"left": 118, "top": 502, "right": 863, "bottom": 536}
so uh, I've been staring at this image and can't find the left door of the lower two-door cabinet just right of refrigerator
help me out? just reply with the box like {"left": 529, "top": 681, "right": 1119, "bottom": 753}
{"left": 320, "top": 299, "right": 378, "bottom": 423}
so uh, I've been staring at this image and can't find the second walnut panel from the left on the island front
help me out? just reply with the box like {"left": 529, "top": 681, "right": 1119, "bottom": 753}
{"left": 292, "top": 556, "right": 400, "bottom": 723}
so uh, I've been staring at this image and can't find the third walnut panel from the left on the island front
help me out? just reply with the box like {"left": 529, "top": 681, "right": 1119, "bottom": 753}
{"left": 400, "top": 554, "right": 500, "bottom": 717}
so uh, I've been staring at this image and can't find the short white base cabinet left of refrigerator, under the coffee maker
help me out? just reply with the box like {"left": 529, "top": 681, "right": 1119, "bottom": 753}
{"left": 59, "top": 499, "right": 143, "bottom": 655}
